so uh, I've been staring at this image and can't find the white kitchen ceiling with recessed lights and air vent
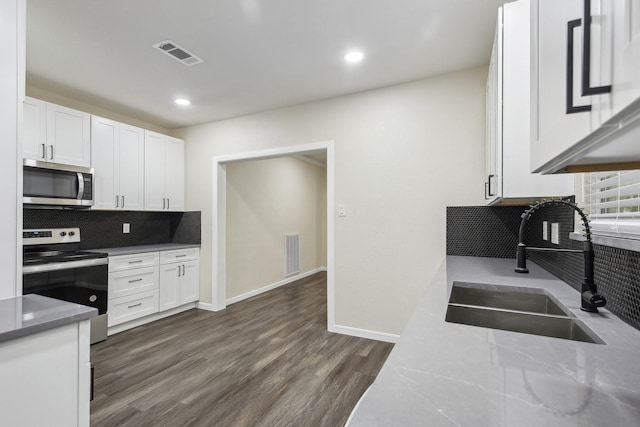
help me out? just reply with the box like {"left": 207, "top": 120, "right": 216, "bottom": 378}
{"left": 27, "top": 0, "right": 506, "bottom": 128}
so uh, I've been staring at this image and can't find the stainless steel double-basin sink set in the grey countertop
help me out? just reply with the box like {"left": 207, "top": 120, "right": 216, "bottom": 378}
{"left": 445, "top": 282, "right": 605, "bottom": 344}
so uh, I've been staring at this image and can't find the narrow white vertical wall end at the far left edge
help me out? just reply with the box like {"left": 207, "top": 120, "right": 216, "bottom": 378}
{"left": 0, "top": 0, "right": 25, "bottom": 299}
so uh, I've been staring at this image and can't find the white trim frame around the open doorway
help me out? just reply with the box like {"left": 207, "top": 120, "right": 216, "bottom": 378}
{"left": 211, "top": 141, "right": 335, "bottom": 331}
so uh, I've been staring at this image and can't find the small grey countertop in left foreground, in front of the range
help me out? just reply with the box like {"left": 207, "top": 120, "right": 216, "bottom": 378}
{"left": 0, "top": 294, "right": 98, "bottom": 343}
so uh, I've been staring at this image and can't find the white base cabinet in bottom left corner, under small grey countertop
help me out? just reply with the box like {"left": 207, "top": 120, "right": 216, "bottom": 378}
{"left": 0, "top": 320, "right": 91, "bottom": 427}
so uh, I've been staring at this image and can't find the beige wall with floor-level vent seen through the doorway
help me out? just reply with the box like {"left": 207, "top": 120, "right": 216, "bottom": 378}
{"left": 226, "top": 157, "right": 326, "bottom": 298}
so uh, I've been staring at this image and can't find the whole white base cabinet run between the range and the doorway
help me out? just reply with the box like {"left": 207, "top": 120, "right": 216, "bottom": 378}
{"left": 108, "top": 248, "right": 200, "bottom": 327}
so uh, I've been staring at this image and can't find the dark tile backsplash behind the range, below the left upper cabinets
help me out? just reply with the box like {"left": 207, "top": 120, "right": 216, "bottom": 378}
{"left": 23, "top": 208, "right": 200, "bottom": 249}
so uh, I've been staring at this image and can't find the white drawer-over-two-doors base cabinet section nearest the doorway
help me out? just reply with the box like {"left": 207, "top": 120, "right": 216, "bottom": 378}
{"left": 160, "top": 248, "right": 200, "bottom": 310}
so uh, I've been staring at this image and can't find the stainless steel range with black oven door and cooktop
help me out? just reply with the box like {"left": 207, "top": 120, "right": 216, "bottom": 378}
{"left": 22, "top": 228, "right": 109, "bottom": 344}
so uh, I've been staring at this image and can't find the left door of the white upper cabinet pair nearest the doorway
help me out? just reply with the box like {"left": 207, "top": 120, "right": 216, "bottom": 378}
{"left": 144, "top": 131, "right": 166, "bottom": 210}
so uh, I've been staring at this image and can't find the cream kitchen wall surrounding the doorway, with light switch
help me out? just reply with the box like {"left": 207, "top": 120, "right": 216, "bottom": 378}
{"left": 176, "top": 67, "right": 487, "bottom": 334}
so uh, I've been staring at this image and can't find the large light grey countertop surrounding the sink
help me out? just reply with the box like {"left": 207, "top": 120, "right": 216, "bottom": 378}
{"left": 348, "top": 256, "right": 640, "bottom": 427}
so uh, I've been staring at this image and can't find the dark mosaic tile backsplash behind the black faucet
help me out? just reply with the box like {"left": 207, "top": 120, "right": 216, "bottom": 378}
{"left": 447, "top": 202, "right": 640, "bottom": 330}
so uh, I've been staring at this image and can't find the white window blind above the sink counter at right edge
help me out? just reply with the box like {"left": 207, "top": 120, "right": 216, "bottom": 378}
{"left": 583, "top": 170, "right": 640, "bottom": 239}
